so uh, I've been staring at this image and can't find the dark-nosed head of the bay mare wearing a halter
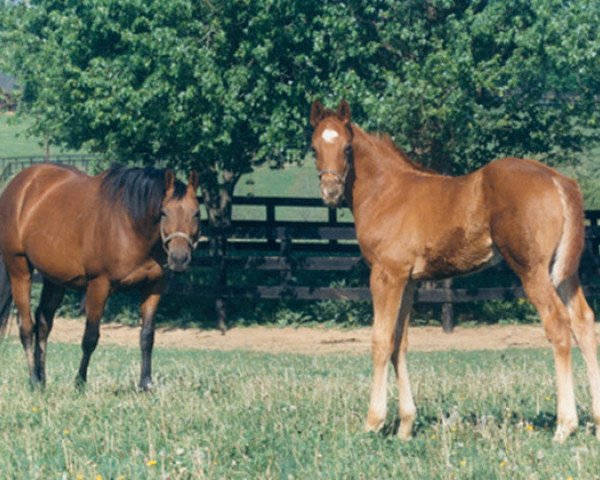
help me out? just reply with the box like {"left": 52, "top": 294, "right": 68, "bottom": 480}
{"left": 160, "top": 170, "right": 200, "bottom": 272}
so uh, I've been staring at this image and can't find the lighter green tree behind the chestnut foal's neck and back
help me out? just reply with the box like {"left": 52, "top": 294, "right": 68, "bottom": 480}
{"left": 316, "top": 0, "right": 600, "bottom": 174}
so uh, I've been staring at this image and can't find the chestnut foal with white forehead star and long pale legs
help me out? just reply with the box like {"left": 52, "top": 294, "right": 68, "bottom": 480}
{"left": 310, "top": 100, "right": 600, "bottom": 442}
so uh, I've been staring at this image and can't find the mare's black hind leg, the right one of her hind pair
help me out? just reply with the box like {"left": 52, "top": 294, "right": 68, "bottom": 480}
{"left": 34, "top": 279, "right": 65, "bottom": 385}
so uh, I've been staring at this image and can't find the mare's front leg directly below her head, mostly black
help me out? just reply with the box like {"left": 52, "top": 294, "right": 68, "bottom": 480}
{"left": 140, "top": 278, "right": 165, "bottom": 391}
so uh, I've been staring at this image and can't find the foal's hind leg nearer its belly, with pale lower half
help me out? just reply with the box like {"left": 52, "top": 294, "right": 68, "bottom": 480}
{"left": 520, "top": 267, "right": 578, "bottom": 442}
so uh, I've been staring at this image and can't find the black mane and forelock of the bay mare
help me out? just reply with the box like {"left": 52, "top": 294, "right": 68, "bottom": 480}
{"left": 100, "top": 165, "right": 186, "bottom": 227}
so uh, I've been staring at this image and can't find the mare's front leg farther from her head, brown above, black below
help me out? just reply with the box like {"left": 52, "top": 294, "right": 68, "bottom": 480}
{"left": 76, "top": 278, "right": 110, "bottom": 387}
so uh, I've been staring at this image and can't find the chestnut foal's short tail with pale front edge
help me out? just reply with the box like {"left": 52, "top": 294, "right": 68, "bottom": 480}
{"left": 551, "top": 176, "right": 585, "bottom": 287}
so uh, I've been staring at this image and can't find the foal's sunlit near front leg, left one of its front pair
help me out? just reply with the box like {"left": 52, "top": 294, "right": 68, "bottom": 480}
{"left": 365, "top": 265, "right": 408, "bottom": 431}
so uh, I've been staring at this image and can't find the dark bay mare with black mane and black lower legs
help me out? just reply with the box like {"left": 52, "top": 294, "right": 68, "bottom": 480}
{"left": 0, "top": 163, "right": 200, "bottom": 390}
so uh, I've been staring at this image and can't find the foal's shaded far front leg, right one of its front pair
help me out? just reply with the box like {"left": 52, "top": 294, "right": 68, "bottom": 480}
{"left": 392, "top": 282, "right": 417, "bottom": 440}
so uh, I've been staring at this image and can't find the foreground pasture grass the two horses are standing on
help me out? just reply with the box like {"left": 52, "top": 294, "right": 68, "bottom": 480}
{"left": 0, "top": 341, "right": 600, "bottom": 479}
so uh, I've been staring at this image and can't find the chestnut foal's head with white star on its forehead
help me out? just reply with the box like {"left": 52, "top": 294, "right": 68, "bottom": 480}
{"left": 310, "top": 100, "right": 353, "bottom": 207}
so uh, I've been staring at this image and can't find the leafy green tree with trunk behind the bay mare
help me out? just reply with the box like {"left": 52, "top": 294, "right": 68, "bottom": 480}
{"left": 4, "top": 0, "right": 324, "bottom": 226}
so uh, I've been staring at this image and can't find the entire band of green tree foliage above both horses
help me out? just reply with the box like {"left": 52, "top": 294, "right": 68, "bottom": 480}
{"left": 2, "top": 0, "right": 600, "bottom": 182}
